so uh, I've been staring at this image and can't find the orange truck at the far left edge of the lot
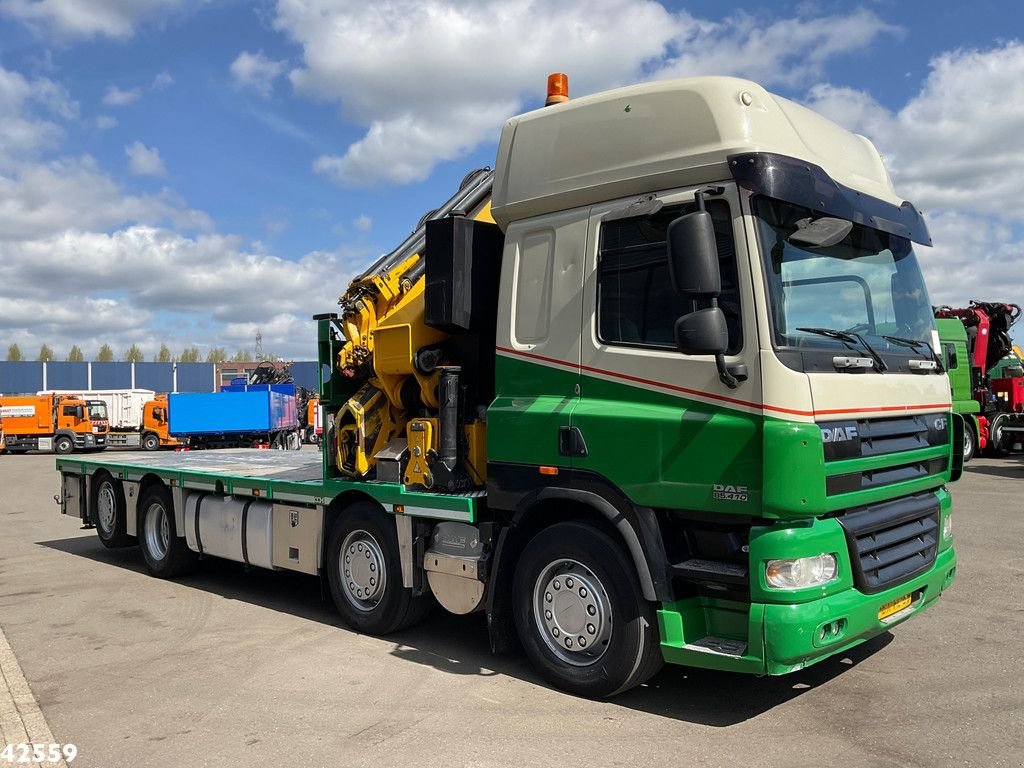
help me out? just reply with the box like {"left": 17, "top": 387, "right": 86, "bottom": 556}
{"left": 0, "top": 394, "right": 109, "bottom": 454}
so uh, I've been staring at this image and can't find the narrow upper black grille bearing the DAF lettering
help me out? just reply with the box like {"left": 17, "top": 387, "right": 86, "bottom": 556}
{"left": 818, "top": 414, "right": 949, "bottom": 462}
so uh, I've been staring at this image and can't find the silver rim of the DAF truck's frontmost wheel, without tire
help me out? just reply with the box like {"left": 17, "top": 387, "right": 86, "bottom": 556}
{"left": 534, "top": 559, "right": 612, "bottom": 667}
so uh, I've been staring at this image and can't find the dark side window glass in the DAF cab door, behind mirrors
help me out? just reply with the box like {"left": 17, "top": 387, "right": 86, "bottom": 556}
{"left": 597, "top": 200, "right": 742, "bottom": 354}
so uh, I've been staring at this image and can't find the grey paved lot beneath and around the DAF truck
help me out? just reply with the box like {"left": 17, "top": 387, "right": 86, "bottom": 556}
{"left": 0, "top": 456, "right": 1024, "bottom": 768}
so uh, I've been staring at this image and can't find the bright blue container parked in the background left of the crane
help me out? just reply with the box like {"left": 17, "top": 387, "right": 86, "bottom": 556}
{"left": 167, "top": 388, "right": 299, "bottom": 435}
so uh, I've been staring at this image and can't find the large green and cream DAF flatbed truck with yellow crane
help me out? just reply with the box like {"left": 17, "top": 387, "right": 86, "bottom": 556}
{"left": 56, "top": 78, "right": 964, "bottom": 697}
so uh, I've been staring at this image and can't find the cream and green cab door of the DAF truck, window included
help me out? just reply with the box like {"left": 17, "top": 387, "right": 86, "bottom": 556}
{"left": 571, "top": 185, "right": 763, "bottom": 512}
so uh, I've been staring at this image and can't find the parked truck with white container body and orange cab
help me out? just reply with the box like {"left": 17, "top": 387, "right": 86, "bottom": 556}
{"left": 38, "top": 389, "right": 184, "bottom": 451}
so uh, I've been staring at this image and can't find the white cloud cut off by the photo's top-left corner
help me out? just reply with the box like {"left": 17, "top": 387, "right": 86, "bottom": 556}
{"left": 0, "top": 0, "right": 188, "bottom": 39}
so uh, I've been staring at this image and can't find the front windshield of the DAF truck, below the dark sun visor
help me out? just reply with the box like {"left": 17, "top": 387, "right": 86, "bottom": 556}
{"left": 755, "top": 197, "right": 935, "bottom": 356}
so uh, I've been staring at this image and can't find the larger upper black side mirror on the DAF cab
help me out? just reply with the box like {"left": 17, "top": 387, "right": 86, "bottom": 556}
{"left": 667, "top": 211, "right": 722, "bottom": 299}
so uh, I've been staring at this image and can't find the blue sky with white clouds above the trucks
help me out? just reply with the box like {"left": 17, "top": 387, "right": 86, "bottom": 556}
{"left": 0, "top": 0, "right": 1024, "bottom": 358}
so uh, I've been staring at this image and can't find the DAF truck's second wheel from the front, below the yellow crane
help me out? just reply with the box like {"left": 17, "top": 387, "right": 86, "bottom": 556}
{"left": 327, "top": 502, "right": 430, "bottom": 635}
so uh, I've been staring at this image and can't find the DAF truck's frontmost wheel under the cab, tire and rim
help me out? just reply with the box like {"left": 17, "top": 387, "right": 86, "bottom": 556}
{"left": 512, "top": 521, "right": 664, "bottom": 698}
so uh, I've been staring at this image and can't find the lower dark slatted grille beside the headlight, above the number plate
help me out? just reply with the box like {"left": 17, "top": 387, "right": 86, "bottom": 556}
{"left": 837, "top": 494, "right": 939, "bottom": 594}
